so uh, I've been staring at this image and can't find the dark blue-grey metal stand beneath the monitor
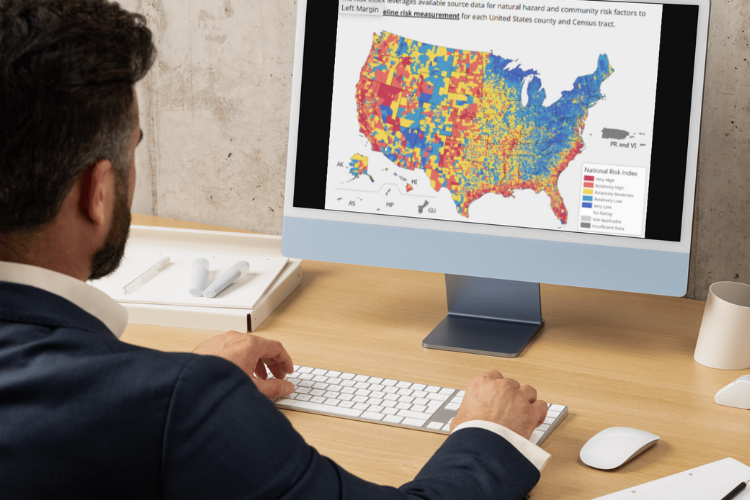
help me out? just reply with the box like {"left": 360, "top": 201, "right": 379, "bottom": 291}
{"left": 422, "top": 274, "right": 544, "bottom": 358}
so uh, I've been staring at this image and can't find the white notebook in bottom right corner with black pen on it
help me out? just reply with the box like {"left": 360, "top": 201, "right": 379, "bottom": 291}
{"left": 596, "top": 458, "right": 750, "bottom": 500}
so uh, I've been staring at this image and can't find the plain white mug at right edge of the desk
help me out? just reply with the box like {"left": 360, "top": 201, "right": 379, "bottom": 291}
{"left": 695, "top": 281, "right": 750, "bottom": 370}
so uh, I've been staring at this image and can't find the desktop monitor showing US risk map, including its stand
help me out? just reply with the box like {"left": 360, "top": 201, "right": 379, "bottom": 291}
{"left": 282, "top": 0, "right": 709, "bottom": 357}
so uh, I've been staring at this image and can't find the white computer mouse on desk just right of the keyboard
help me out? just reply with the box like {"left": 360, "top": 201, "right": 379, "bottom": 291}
{"left": 581, "top": 427, "right": 659, "bottom": 470}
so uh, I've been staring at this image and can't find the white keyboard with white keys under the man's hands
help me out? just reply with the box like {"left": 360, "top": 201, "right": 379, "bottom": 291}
{"left": 269, "top": 365, "right": 568, "bottom": 445}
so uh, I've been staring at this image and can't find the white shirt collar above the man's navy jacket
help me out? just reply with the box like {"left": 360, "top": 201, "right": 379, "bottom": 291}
{"left": 0, "top": 261, "right": 128, "bottom": 339}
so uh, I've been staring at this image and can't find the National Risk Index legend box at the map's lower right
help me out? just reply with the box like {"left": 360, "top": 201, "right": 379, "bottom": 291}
{"left": 578, "top": 164, "right": 647, "bottom": 237}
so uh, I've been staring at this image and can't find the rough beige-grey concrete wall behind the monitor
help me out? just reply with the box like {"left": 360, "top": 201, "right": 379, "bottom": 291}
{"left": 121, "top": 0, "right": 750, "bottom": 300}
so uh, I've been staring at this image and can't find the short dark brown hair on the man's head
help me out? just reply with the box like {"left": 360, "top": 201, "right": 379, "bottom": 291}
{"left": 0, "top": 0, "right": 155, "bottom": 234}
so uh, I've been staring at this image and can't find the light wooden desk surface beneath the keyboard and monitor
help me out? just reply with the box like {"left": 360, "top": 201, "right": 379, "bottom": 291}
{"left": 122, "top": 215, "right": 750, "bottom": 500}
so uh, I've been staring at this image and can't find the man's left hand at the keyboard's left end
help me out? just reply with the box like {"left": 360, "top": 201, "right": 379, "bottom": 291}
{"left": 193, "top": 332, "right": 294, "bottom": 399}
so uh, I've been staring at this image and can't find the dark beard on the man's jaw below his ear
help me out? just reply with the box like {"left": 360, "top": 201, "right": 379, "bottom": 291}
{"left": 89, "top": 179, "right": 130, "bottom": 280}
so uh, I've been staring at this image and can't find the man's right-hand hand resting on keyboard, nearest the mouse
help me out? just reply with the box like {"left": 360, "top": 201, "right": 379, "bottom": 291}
{"left": 451, "top": 371, "right": 547, "bottom": 439}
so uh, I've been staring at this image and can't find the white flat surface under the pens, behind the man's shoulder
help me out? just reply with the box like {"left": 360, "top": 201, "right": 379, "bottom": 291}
{"left": 89, "top": 248, "right": 289, "bottom": 309}
